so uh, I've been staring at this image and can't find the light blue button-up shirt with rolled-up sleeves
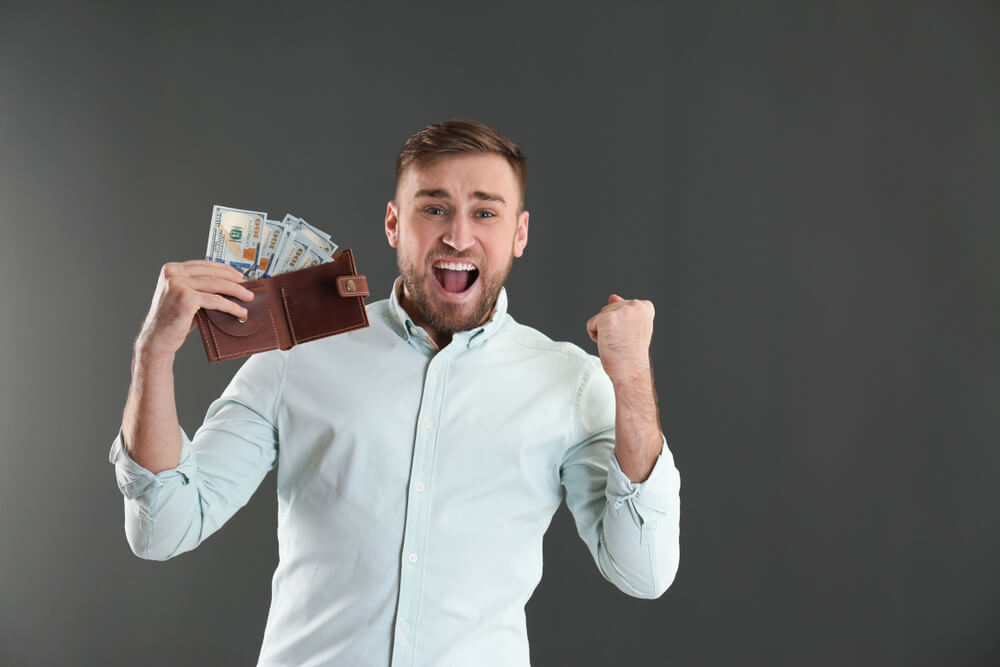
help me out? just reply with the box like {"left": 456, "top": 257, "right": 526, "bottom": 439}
{"left": 110, "top": 280, "right": 680, "bottom": 667}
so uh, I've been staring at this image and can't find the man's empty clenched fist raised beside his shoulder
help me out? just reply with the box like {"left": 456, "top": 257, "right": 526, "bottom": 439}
{"left": 587, "top": 294, "right": 655, "bottom": 383}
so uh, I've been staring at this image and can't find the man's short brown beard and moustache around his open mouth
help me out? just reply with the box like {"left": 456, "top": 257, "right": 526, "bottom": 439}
{"left": 396, "top": 244, "right": 514, "bottom": 334}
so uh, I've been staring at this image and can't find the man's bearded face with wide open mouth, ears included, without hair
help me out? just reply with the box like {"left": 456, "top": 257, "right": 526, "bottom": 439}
{"left": 385, "top": 153, "right": 528, "bottom": 334}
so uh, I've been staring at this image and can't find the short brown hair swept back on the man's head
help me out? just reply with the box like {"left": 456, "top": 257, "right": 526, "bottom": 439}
{"left": 396, "top": 120, "right": 528, "bottom": 209}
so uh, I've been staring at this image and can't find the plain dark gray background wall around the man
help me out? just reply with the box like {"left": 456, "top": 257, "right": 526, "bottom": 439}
{"left": 0, "top": 2, "right": 1000, "bottom": 665}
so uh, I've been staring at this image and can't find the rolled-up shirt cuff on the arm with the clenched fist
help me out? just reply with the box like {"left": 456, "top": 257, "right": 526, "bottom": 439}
{"left": 606, "top": 434, "right": 680, "bottom": 544}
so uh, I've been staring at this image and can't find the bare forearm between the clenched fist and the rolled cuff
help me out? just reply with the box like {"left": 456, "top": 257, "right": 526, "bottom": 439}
{"left": 612, "top": 367, "right": 663, "bottom": 483}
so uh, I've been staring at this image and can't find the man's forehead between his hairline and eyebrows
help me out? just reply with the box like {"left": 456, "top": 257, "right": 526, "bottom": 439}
{"left": 397, "top": 153, "right": 520, "bottom": 200}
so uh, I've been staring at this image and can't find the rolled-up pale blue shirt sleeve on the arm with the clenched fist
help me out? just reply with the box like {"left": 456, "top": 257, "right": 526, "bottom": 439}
{"left": 561, "top": 362, "right": 680, "bottom": 598}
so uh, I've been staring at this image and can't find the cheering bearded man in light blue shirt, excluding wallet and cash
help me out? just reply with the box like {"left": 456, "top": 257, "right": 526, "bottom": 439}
{"left": 110, "top": 121, "right": 680, "bottom": 667}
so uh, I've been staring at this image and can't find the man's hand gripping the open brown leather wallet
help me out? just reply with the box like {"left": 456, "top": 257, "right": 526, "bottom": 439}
{"left": 135, "top": 259, "right": 254, "bottom": 357}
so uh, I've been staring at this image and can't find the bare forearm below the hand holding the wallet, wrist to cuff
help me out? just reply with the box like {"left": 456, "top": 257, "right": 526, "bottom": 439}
{"left": 122, "top": 345, "right": 181, "bottom": 473}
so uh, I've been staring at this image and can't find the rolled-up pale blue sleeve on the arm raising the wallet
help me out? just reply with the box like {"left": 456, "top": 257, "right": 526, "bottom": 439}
{"left": 108, "top": 351, "right": 284, "bottom": 560}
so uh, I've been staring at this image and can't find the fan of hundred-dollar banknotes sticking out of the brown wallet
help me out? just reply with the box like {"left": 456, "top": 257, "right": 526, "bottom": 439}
{"left": 205, "top": 206, "right": 337, "bottom": 280}
